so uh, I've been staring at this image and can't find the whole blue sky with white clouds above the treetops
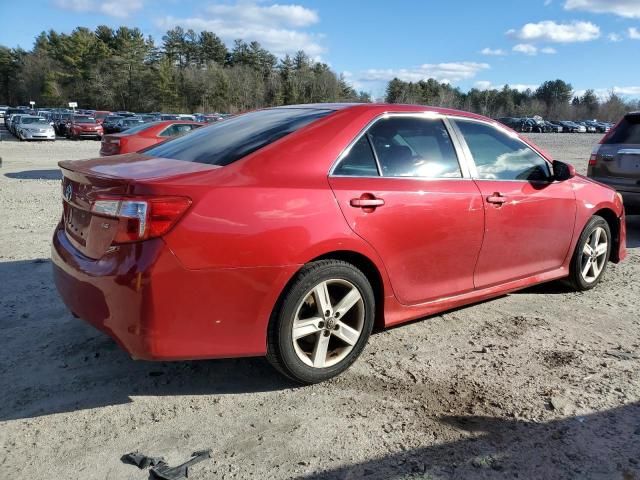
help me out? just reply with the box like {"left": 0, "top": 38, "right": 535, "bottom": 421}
{"left": 0, "top": 0, "right": 640, "bottom": 97}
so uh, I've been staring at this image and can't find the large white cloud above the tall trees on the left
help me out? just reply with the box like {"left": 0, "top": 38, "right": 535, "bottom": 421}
{"left": 156, "top": 2, "right": 326, "bottom": 59}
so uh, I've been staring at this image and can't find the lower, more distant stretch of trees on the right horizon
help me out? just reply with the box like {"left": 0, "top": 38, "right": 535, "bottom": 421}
{"left": 385, "top": 78, "right": 640, "bottom": 121}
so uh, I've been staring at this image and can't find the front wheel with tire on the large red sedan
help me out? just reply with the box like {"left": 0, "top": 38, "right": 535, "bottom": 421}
{"left": 567, "top": 215, "right": 612, "bottom": 292}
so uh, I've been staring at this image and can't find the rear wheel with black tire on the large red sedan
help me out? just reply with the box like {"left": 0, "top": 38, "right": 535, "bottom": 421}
{"left": 267, "top": 260, "right": 375, "bottom": 385}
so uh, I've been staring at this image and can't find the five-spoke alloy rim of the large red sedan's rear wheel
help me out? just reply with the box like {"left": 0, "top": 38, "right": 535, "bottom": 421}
{"left": 292, "top": 279, "right": 365, "bottom": 368}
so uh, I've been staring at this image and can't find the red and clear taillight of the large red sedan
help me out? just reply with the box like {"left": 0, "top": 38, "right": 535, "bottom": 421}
{"left": 91, "top": 197, "right": 191, "bottom": 243}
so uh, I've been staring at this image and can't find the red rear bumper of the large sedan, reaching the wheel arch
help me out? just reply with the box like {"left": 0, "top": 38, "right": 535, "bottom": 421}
{"left": 51, "top": 225, "right": 298, "bottom": 360}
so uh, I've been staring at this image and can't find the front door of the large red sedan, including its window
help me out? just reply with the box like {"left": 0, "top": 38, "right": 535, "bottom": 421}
{"left": 453, "top": 119, "right": 576, "bottom": 288}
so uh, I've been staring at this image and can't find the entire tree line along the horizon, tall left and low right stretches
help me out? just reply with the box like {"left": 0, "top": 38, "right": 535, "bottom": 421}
{"left": 0, "top": 25, "right": 640, "bottom": 121}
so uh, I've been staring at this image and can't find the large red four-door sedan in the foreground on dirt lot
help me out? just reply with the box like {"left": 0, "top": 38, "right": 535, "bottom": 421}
{"left": 52, "top": 104, "right": 626, "bottom": 383}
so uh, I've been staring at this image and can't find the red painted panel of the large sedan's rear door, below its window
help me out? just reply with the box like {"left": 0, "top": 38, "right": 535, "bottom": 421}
{"left": 331, "top": 177, "right": 484, "bottom": 305}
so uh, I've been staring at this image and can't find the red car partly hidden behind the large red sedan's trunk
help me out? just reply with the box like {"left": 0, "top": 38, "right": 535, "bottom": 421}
{"left": 100, "top": 120, "right": 206, "bottom": 156}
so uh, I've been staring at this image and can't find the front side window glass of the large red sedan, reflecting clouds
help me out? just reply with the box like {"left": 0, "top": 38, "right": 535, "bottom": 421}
{"left": 455, "top": 120, "right": 551, "bottom": 181}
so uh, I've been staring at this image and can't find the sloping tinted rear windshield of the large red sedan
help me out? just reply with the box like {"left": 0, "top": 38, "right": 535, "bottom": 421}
{"left": 144, "top": 108, "right": 332, "bottom": 166}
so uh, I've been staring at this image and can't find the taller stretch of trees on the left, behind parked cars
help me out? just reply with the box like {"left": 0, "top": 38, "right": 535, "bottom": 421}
{"left": 0, "top": 26, "right": 370, "bottom": 113}
